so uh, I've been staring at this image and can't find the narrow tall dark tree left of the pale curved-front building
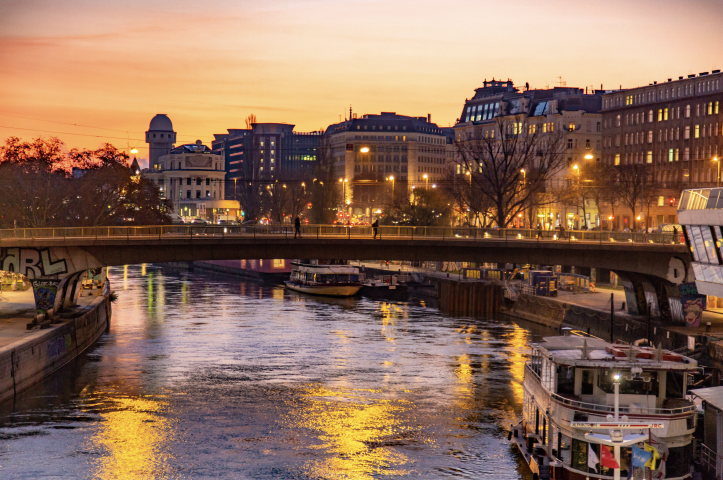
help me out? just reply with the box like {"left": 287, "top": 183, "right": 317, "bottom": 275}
{"left": 311, "top": 138, "right": 341, "bottom": 224}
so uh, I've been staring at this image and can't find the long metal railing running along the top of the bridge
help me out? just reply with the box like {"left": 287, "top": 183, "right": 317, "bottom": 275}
{"left": 0, "top": 224, "right": 684, "bottom": 244}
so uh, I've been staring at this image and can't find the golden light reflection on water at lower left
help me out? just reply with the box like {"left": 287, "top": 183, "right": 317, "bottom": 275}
{"left": 89, "top": 397, "right": 177, "bottom": 480}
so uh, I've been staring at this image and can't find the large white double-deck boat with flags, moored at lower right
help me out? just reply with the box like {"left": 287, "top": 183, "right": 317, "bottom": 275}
{"left": 509, "top": 333, "right": 698, "bottom": 480}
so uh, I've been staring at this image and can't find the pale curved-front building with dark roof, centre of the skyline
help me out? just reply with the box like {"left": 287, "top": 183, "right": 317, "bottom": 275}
{"left": 325, "top": 112, "right": 453, "bottom": 221}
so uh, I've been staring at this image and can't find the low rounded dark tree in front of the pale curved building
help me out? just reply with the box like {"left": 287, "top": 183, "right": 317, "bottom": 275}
{"left": 385, "top": 188, "right": 451, "bottom": 226}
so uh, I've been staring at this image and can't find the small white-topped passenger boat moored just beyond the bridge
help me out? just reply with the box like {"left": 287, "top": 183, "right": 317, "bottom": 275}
{"left": 284, "top": 260, "right": 362, "bottom": 297}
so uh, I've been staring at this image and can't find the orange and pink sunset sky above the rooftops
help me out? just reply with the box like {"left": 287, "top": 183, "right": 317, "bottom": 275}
{"left": 0, "top": 0, "right": 723, "bottom": 165}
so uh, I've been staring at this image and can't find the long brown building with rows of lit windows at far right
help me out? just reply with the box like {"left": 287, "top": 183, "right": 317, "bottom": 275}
{"left": 602, "top": 70, "right": 723, "bottom": 228}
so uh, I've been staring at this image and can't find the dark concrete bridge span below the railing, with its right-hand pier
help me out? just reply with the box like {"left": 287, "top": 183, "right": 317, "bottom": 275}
{"left": 0, "top": 240, "right": 693, "bottom": 317}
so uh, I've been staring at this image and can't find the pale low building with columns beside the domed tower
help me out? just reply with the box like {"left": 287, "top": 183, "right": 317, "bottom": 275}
{"left": 142, "top": 133, "right": 241, "bottom": 222}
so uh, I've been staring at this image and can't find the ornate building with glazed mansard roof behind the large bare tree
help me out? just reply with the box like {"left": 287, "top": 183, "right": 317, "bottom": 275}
{"left": 454, "top": 79, "right": 602, "bottom": 228}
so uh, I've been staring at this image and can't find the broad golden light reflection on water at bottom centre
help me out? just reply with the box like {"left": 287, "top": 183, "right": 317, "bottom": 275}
{"left": 287, "top": 386, "right": 419, "bottom": 480}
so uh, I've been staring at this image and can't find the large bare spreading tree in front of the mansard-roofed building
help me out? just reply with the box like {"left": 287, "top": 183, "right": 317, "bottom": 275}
{"left": 455, "top": 115, "right": 565, "bottom": 228}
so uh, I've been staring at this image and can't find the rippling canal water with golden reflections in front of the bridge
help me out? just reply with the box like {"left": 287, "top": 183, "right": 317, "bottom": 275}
{"left": 0, "top": 265, "right": 535, "bottom": 480}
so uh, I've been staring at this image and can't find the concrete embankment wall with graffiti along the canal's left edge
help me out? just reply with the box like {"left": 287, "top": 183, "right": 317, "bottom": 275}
{"left": 0, "top": 295, "right": 111, "bottom": 402}
